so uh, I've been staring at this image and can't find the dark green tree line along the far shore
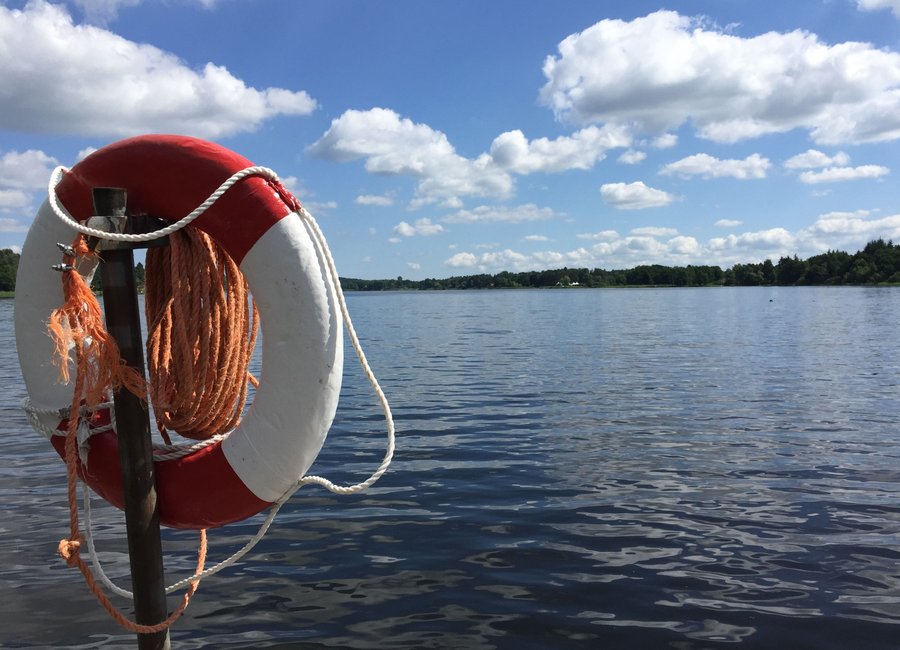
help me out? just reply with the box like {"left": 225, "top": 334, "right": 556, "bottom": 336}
{"left": 0, "top": 239, "right": 900, "bottom": 292}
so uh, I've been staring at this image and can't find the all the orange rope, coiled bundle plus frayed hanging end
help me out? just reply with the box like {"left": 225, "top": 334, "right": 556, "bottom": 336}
{"left": 49, "top": 229, "right": 259, "bottom": 634}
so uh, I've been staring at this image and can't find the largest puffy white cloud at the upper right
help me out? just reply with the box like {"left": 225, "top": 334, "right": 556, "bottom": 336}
{"left": 540, "top": 11, "right": 900, "bottom": 144}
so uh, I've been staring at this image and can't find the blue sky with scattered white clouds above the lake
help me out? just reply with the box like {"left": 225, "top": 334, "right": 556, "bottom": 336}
{"left": 0, "top": 0, "right": 900, "bottom": 280}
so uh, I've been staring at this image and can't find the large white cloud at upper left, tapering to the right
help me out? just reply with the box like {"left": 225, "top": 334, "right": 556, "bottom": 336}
{"left": 0, "top": 0, "right": 316, "bottom": 138}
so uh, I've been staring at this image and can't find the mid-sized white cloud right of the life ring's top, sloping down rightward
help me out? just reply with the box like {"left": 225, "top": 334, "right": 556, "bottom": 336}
{"left": 308, "top": 108, "right": 513, "bottom": 206}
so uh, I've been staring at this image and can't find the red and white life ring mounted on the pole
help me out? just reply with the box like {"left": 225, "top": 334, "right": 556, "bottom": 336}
{"left": 15, "top": 135, "right": 343, "bottom": 528}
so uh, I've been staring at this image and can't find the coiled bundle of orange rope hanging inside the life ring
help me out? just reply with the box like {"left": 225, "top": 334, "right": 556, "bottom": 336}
{"left": 144, "top": 228, "right": 259, "bottom": 440}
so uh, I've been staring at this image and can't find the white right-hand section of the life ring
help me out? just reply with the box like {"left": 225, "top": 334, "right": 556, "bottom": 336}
{"left": 222, "top": 213, "right": 344, "bottom": 501}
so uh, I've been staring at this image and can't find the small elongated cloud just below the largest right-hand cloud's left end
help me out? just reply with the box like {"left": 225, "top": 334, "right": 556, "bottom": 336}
{"left": 490, "top": 125, "right": 631, "bottom": 174}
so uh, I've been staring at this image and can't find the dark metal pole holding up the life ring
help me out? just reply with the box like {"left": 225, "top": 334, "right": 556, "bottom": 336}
{"left": 93, "top": 188, "right": 170, "bottom": 650}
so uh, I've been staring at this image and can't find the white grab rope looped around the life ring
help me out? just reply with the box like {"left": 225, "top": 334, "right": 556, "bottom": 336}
{"left": 36, "top": 167, "right": 396, "bottom": 598}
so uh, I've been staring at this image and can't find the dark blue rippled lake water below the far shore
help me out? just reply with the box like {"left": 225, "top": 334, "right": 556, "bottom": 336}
{"left": 0, "top": 288, "right": 900, "bottom": 650}
